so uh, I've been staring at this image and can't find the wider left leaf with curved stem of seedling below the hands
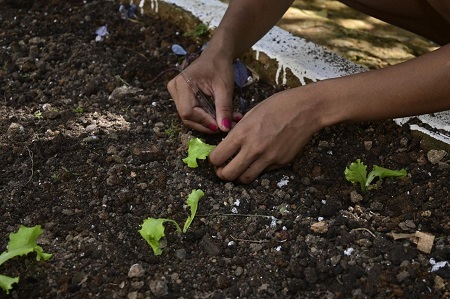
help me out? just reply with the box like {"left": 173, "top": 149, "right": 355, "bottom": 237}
{"left": 139, "top": 218, "right": 181, "bottom": 255}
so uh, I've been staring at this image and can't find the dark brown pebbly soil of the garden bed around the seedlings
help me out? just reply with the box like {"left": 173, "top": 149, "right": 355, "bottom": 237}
{"left": 0, "top": 0, "right": 450, "bottom": 299}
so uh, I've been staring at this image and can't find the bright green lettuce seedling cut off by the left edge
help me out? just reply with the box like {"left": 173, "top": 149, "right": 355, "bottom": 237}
{"left": 0, "top": 225, "right": 52, "bottom": 294}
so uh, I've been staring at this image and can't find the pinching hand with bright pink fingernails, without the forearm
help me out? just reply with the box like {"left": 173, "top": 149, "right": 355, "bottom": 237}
{"left": 167, "top": 51, "right": 242, "bottom": 133}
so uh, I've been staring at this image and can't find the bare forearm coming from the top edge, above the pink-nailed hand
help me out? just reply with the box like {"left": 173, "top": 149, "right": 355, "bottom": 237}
{"left": 207, "top": 0, "right": 293, "bottom": 59}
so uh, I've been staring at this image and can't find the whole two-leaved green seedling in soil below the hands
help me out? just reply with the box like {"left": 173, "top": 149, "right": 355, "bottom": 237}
{"left": 139, "top": 189, "right": 205, "bottom": 255}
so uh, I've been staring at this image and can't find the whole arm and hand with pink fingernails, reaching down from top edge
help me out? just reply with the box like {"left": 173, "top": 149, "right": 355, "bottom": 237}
{"left": 167, "top": 0, "right": 293, "bottom": 133}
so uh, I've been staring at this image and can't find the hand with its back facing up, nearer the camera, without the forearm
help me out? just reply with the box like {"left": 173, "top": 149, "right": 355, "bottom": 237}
{"left": 209, "top": 87, "right": 323, "bottom": 184}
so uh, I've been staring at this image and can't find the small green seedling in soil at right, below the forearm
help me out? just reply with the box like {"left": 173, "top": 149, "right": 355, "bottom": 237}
{"left": 344, "top": 159, "right": 406, "bottom": 192}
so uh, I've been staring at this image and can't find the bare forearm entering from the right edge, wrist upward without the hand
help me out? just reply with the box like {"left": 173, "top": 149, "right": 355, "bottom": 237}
{"left": 318, "top": 45, "right": 450, "bottom": 126}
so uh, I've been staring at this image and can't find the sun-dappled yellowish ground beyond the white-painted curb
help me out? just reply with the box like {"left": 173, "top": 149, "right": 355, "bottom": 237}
{"left": 278, "top": 0, "right": 436, "bottom": 68}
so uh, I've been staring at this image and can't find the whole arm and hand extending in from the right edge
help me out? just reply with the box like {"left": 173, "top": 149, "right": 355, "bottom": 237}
{"left": 210, "top": 45, "right": 450, "bottom": 183}
